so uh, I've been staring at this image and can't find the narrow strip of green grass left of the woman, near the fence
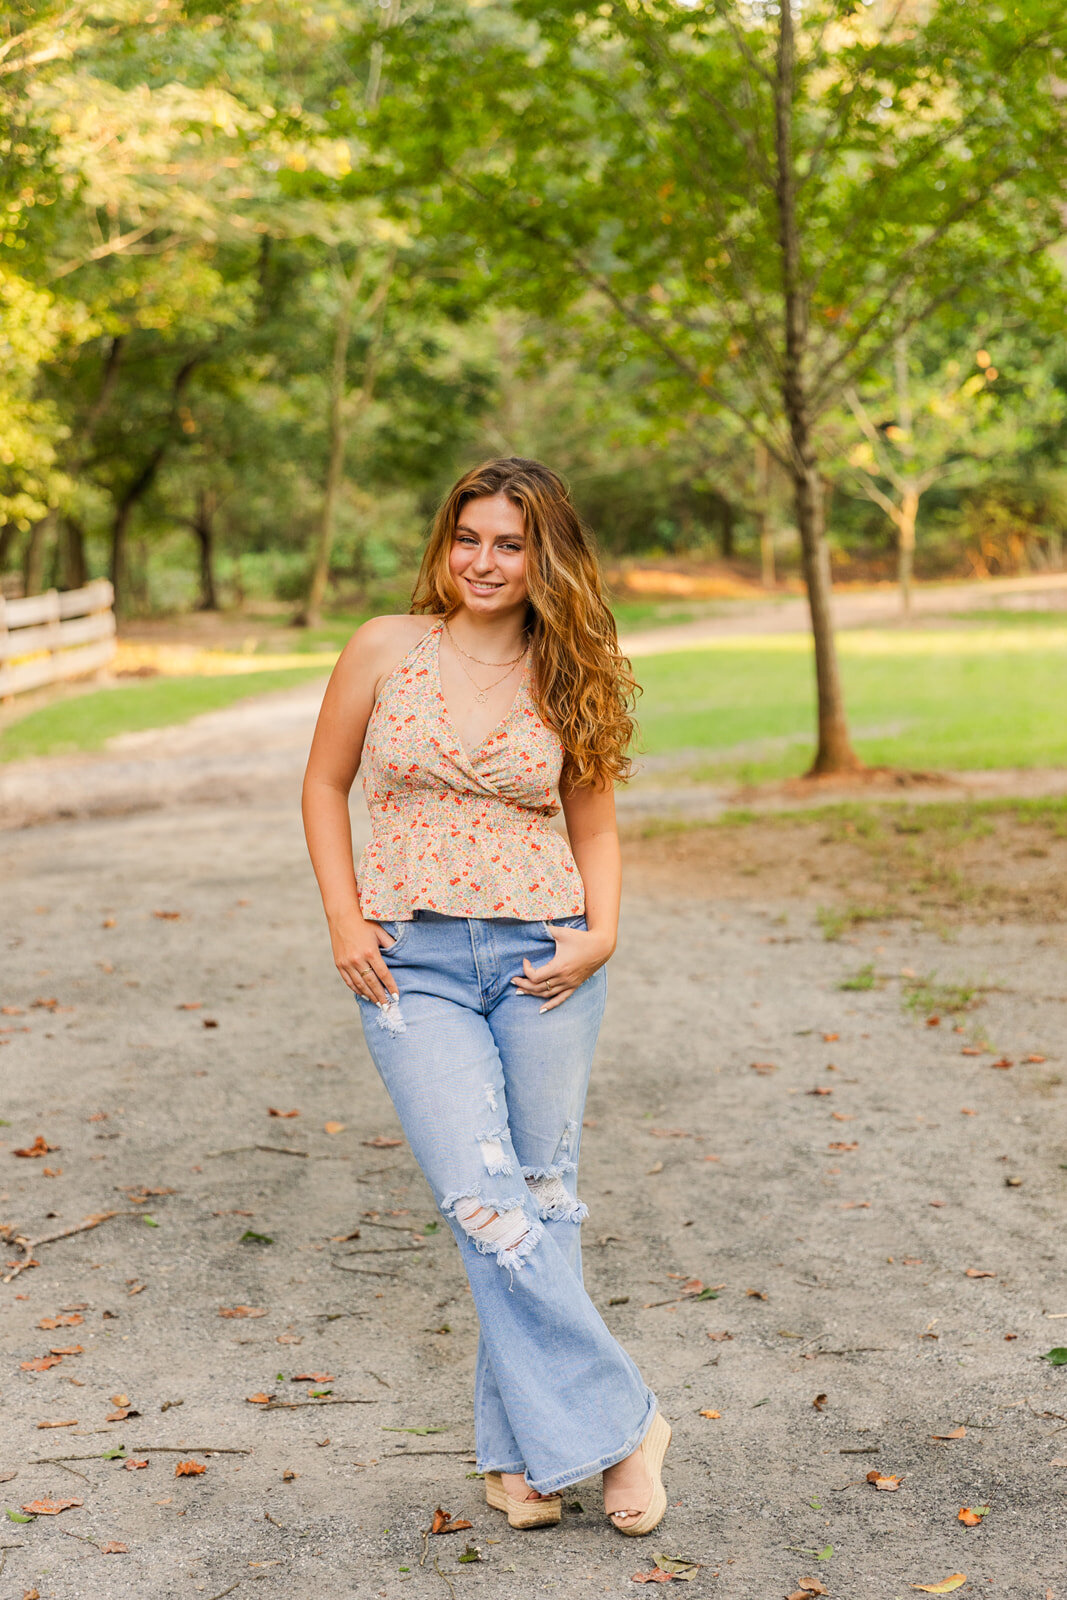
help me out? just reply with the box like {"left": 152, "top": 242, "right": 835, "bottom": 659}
{"left": 0, "top": 667, "right": 323, "bottom": 762}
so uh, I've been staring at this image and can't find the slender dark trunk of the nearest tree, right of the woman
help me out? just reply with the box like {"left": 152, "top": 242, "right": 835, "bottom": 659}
{"left": 774, "top": 0, "right": 862, "bottom": 776}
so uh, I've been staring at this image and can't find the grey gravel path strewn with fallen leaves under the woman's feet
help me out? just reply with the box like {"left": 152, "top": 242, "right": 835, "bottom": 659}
{"left": 0, "top": 764, "right": 1067, "bottom": 1600}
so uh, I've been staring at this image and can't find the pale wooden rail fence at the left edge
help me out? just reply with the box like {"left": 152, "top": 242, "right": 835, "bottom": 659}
{"left": 0, "top": 578, "right": 115, "bottom": 699}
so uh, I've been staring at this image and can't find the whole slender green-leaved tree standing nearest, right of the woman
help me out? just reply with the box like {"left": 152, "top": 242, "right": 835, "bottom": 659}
{"left": 364, "top": 0, "right": 1067, "bottom": 773}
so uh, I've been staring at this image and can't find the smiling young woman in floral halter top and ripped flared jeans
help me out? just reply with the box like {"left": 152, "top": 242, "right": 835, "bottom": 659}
{"left": 304, "top": 458, "right": 670, "bottom": 1534}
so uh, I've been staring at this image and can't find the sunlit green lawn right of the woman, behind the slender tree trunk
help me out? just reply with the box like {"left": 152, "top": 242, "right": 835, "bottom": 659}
{"left": 637, "top": 614, "right": 1067, "bottom": 781}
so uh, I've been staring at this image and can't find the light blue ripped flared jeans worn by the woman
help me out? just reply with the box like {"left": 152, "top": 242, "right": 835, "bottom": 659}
{"left": 358, "top": 910, "right": 656, "bottom": 1494}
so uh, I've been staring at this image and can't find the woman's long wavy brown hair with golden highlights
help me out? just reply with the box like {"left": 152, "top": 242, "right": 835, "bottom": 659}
{"left": 411, "top": 456, "right": 640, "bottom": 789}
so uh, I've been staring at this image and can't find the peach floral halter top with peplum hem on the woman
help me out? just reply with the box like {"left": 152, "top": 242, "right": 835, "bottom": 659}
{"left": 357, "top": 622, "right": 585, "bottom": 922}
